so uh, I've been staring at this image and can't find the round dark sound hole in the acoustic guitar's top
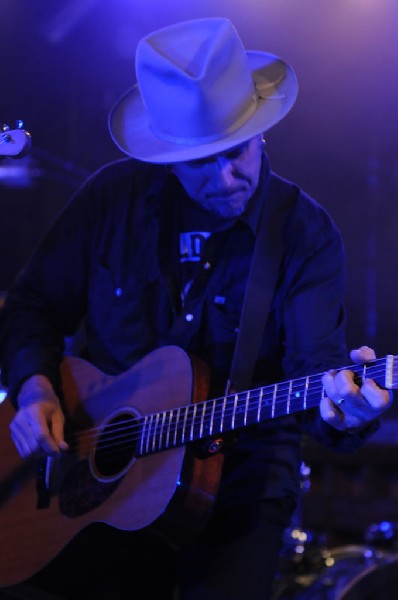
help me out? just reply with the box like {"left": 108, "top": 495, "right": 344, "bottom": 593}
{"left": 94, "top": 412, "right": 137, "bottom": 479}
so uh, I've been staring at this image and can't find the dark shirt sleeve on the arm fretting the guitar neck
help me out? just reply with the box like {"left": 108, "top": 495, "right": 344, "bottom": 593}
{"left": 283, "top": 192, "right": 379, "bottom": 452}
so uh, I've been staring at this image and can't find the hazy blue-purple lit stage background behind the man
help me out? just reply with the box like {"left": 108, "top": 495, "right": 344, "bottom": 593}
{"left": 0, "top": 0, "right": 398, "bottom": 556}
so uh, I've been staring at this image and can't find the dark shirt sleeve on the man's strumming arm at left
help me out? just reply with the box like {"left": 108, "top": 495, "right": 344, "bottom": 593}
{"left": 0, "top": 172, "right": 94, "bottom": 404}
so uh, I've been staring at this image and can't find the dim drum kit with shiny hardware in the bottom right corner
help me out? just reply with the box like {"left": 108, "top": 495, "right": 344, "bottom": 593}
{"left": 272, "top": 463, "right": 398, "bottom": 600}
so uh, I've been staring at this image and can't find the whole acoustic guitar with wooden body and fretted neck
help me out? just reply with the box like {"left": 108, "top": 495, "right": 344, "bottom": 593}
{"left": 0, "top": 346, "right": 398, "bottom": 587}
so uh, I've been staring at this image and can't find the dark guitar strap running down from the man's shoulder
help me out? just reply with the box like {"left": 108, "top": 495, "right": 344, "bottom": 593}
{"left": 226, "top": 173, "right": 298, "bottom": 394}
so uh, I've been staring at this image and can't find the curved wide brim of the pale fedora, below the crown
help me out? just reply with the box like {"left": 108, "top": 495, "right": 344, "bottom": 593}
{"left": 108, "top": 51, "right": 298, "bottom": 163}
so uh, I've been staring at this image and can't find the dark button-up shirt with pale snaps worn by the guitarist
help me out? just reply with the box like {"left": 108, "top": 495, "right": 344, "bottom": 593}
{"left": 0, "top": 155, "right": 374, "bottom": 501}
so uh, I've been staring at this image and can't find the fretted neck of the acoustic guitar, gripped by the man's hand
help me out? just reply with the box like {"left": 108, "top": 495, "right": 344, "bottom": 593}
{"left": 137, "top": 355, "right": 398, "bottom": 456}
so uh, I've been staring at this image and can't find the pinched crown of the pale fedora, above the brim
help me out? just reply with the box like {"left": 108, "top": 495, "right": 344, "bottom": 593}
{"left": 136, "top": 19, "right": 257, "bottom": 144}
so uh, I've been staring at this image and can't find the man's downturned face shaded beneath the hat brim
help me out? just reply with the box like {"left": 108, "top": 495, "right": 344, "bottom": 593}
{"left": 171, "top": 135, "right": 262, "bottom": 218}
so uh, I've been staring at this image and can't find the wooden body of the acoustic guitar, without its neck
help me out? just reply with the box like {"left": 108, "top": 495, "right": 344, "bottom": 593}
{"left": 0, "top": 346, "right": 221, "bottom": 587}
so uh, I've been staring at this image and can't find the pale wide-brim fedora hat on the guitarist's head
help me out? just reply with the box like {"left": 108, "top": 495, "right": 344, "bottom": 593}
{"left": 109, "top": 18, "right": 298, "bottom": 163}
